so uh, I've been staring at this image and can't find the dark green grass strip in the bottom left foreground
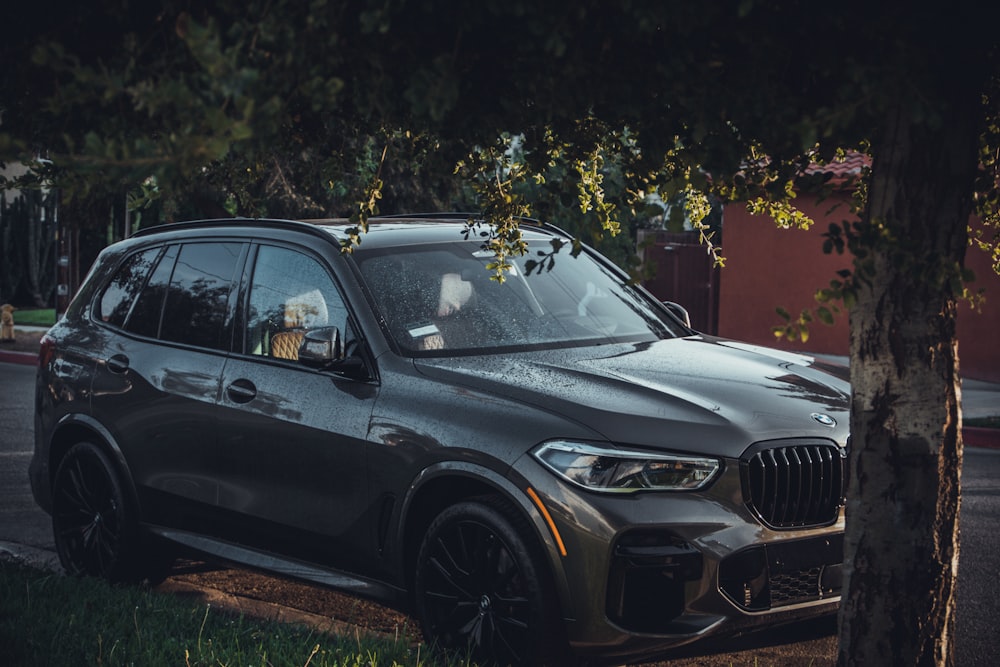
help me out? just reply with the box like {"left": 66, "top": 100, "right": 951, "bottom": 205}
{"left": 0, "top": 562, "right": 467, "bottom": 667}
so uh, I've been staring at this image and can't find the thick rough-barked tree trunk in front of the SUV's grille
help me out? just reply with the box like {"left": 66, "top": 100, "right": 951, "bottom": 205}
{"left": 838, "top": 91, "right": 979, "bottom": 667}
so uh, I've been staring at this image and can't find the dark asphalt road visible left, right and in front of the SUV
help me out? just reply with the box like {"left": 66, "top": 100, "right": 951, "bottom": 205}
{"left": 0, "top": 363, "right": 1000, "bottom": 667}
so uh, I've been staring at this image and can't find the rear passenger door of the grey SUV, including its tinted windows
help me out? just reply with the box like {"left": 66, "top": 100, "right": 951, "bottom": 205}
{"left": 91, "top": 241, "right": 249, "bottom": 529}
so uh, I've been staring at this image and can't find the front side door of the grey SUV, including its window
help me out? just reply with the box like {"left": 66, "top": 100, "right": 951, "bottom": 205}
{"left": 218, "top": 244, "right": 377, "bottom": 568}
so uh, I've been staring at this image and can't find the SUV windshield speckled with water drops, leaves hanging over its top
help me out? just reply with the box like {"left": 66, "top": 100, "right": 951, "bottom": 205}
{"left": 355, "top": 240, "right": 688, "bottom": 355}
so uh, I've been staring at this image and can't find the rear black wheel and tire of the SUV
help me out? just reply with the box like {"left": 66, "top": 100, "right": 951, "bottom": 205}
{"left": 52, "top": 442, "right": 173, "bottom": 584}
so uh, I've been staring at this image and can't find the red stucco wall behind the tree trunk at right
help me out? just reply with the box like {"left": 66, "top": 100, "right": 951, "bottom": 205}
{"left": 719, "top": 199, "right": 1000, "bottom": 382}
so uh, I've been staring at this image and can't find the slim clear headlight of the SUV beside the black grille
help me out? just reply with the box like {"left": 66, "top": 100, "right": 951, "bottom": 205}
{"left": 531, "top": 440, "right": 720, "bottom": 493}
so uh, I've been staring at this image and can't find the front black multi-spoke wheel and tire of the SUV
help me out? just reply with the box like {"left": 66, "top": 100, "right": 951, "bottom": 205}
{"left": 414, "top": 498, "right": 568, "bottom": 665}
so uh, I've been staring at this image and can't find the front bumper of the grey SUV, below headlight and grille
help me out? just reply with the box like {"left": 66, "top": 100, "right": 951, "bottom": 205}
{"left": 522, "top": 454, "right": 844, "bottom": 659}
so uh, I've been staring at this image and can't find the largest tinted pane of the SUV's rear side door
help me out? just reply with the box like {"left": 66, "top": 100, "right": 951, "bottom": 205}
{"left": 160, "top": 243, "right": 242, "bottom": 350}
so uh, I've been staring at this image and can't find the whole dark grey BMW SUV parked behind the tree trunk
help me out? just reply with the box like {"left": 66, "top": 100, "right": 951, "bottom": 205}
{"left": 30, "top": 215, "right": 849, "bottom": 664}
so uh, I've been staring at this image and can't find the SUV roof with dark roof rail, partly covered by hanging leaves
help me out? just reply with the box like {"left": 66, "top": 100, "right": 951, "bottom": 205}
{"left": 134, "top": 213, "right": 569, "bottom": 249}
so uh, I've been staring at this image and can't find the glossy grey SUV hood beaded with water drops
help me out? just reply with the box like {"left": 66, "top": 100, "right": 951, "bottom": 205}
{"left": 416, "top": 336, "right": 850, "bottom": 457}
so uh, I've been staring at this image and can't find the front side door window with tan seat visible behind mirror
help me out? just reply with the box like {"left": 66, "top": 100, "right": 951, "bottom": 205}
{"left": 244, "top": 246, "right": 347, "bottom": 360}
